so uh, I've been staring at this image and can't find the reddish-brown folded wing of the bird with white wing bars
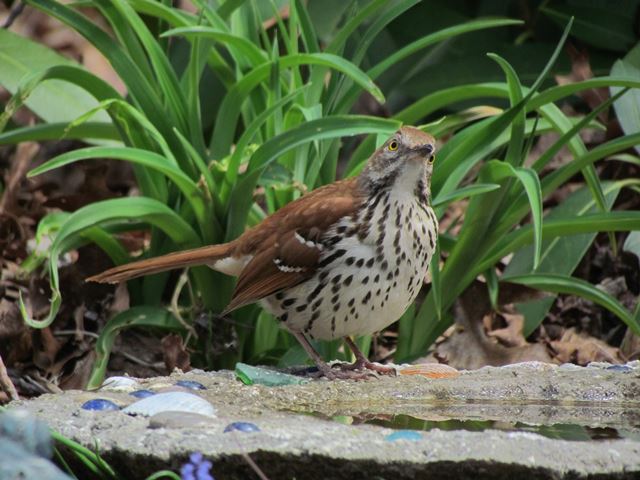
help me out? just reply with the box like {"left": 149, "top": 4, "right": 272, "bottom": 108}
{"left": 226, "top": 179, "right": 363, "bottom": 312}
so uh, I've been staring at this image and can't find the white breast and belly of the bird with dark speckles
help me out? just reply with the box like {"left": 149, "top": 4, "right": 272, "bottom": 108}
{"left": 263, "top": 190, "right": 437, "bottom": 340}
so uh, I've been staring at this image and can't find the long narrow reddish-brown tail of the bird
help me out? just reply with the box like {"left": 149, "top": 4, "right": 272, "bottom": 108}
{"left": 87, "top": 243, "right": 232, "bottom": 283}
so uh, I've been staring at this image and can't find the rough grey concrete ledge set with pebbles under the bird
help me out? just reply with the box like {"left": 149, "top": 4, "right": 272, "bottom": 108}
{"left": 15, "top": 364, "right": 640, "bottom": 480}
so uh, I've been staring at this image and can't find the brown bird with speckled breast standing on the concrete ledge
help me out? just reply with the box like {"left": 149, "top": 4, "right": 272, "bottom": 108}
{"left": 89, "top": 127, "right": 438, "bottom": 378}
